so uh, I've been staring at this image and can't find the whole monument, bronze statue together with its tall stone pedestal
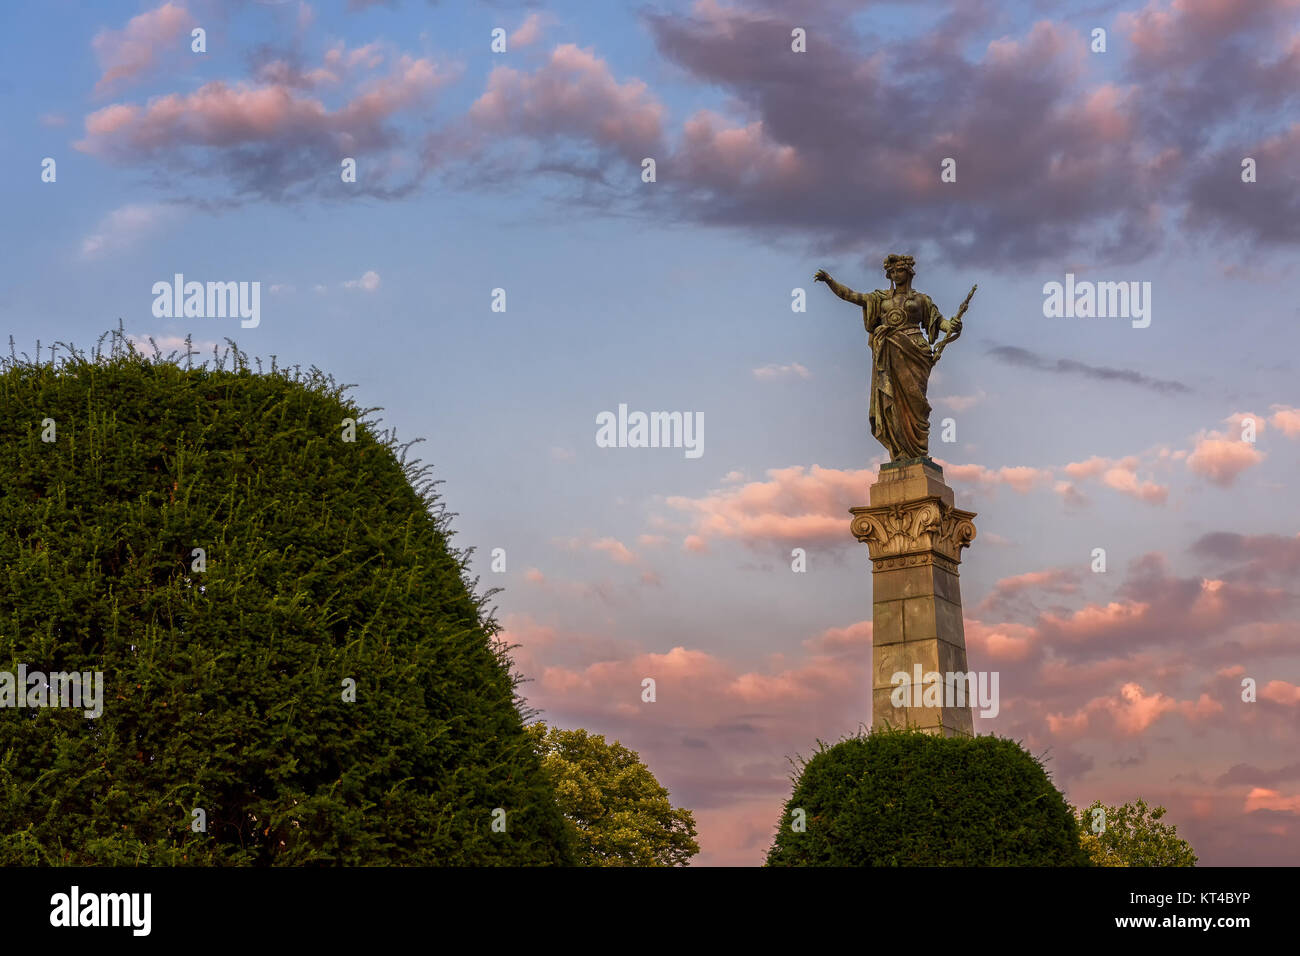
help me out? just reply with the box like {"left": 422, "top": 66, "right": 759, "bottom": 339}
{"left": 815, "top": 255, "right": 975, "bottom": 736}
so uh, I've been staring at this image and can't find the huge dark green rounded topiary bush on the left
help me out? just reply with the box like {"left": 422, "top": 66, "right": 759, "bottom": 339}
{"left": 0, "top": 333, "right": 572, "bottom": 865}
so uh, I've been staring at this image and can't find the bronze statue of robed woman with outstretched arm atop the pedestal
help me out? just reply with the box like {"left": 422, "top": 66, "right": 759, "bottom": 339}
{"left": 814, "top": 255, "right": 978, "bottom": 462}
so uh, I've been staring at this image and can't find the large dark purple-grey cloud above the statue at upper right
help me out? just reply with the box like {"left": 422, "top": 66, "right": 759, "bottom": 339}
{"left": 634, "top": 0, "right": 1300, "bottom": 267}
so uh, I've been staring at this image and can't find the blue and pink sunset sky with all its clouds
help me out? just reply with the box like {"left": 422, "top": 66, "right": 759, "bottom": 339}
{"left": 0, "top": 0, "right": 1300, "bottom": 865}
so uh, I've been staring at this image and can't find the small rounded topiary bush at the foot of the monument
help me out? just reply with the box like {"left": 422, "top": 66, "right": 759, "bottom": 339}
{"left": 767, "top": 730, "right": 1088, "bottom": 866}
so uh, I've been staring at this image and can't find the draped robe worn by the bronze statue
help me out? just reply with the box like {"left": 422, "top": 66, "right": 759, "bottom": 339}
{"left": 862, "top": 289, "right": 944, "bottom": 462}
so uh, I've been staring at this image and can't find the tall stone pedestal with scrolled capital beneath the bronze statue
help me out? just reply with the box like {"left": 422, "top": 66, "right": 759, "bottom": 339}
{"left": 849, "top": 458, "right": 975, "bottom": 736}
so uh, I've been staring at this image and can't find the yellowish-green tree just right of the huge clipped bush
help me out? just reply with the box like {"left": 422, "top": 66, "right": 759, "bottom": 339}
{"left": 528, "top": 722, "right": 699, "bottom": 866}
